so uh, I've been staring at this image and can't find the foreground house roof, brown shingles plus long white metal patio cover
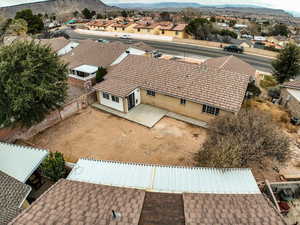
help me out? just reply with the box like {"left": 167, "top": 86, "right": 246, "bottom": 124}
{"left": 9, "top": 159, "right": 286, "bottom": 225}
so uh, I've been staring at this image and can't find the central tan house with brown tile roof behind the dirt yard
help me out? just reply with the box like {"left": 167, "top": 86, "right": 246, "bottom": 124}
{"left": 94, "top": 55, "right": 256, "bottom": 122}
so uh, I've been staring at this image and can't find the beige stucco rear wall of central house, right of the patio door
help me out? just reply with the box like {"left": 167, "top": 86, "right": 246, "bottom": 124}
{"left": 141, "top": 89, "right": 231, "bottom": 122}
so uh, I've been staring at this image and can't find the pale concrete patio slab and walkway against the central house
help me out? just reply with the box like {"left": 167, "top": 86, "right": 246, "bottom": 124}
{"left": 92, "top": 103, "right": 168, "bottom": 128}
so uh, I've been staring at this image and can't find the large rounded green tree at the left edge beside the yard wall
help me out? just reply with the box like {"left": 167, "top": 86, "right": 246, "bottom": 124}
{"left": 0, "top": 41, "right": 68, "bottom": 127}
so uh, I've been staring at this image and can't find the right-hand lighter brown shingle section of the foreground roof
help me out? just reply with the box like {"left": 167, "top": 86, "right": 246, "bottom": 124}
{"left": 183, "top": 194, "right": 286, "bottom": 225}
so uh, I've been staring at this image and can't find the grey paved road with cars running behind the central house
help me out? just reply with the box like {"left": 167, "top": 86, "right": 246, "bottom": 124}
{"left": 66, "top": 30, "right": 272, "bottom": 72}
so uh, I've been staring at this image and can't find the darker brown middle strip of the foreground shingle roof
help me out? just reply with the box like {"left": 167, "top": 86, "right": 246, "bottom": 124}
{"left": 139, "top": 192, "right": 185, "bottom": 225}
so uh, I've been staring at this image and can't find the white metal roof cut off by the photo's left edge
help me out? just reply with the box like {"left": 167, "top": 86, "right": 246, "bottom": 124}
{"left": 0, "top": 142, "right": 48, "bottom": 183}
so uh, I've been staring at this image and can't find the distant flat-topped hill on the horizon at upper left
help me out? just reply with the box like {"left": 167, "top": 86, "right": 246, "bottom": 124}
{"left": 0, "top": 0, "right": 115, "bottom": 17}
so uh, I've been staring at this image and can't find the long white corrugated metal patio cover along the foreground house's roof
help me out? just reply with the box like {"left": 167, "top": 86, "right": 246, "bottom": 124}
{"left": 68, "top": 159, "right": 260, "bottom": 194}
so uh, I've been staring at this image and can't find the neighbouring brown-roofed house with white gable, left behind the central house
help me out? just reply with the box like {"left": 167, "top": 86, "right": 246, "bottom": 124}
{"left": 61, "top": 40, "right": 152, "bottom": 89}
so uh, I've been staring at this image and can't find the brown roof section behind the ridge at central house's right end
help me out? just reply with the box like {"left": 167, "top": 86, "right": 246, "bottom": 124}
{"left": 205, "top": 55, "right": 256, "bottom": 77}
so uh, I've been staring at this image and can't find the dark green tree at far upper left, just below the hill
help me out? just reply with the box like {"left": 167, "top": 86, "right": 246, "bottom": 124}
{"left": 15, "top": 9, "right": 44, "bottom": 34}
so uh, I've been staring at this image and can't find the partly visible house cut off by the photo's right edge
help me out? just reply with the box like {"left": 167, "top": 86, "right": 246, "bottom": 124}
{"left": 280, "top": 80, "right": 300, "bottom": 119}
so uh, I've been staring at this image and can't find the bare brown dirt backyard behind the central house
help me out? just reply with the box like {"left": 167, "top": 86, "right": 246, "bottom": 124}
{"left": 29, "top": 108, "right": 206, "bottom": 166}
